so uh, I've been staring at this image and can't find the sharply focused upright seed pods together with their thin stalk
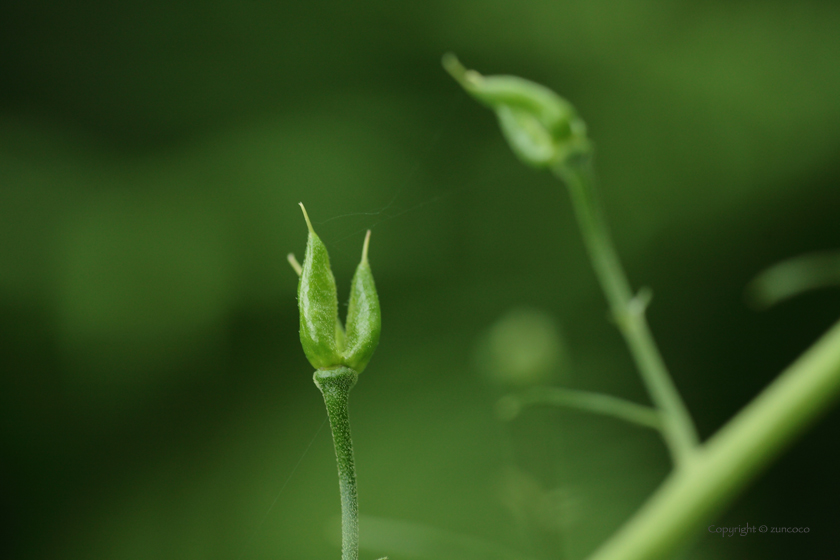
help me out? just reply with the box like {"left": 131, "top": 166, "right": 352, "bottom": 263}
{"left": 288, "top": 204, "right": 381, "bottom": 560}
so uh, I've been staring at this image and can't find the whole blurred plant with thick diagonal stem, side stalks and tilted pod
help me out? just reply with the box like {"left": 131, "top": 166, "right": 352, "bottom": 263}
{"left": 443, "top": 55, "right": 840, "bottom": 560}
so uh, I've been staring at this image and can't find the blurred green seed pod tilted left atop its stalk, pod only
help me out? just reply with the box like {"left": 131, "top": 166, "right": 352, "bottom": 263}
{"left": 443, "top": 54, "right": 590, "bottom": 168}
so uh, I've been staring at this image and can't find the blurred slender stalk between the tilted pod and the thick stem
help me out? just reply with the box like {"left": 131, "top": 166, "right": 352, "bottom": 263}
{"left": 554, "top": 158, "right": 698, "bottom": 465}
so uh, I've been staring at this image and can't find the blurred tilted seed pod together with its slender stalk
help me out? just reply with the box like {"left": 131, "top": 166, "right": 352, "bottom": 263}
{"left": 443, "top": 54, "right": 698, "bottom": 465}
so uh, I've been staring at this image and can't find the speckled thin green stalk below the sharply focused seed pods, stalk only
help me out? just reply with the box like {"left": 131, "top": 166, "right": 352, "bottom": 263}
{"left": 314, "top": 366, "right": 359, "bottom": 560}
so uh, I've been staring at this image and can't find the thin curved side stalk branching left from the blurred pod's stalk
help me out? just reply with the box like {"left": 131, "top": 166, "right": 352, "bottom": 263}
{"left": 499, "top": 387, "right": 662, "bottom": 430}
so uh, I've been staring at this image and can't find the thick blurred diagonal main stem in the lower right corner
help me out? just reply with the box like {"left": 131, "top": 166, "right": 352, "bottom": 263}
{"left": 589, "top": 322, "right": 840, "bottom": 560}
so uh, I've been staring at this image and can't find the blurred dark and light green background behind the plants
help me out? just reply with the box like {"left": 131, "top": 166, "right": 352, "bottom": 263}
{"left": 0, "top": 0, "right": 840, "bottom": 560}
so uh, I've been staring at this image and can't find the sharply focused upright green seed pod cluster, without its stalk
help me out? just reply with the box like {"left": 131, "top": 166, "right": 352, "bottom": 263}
{"left": 289, "top": 204, "right": 381, "bottom": 373}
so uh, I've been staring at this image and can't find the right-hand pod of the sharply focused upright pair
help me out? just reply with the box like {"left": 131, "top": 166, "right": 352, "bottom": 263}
{"left": 344, "top": 230, "right": 382, "bottom": 373}
